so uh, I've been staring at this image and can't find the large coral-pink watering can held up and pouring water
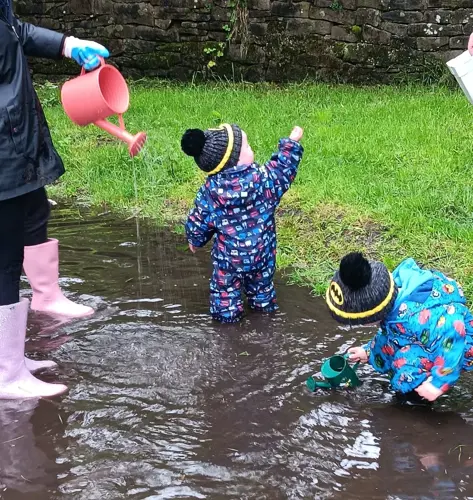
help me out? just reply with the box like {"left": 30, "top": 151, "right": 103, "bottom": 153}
{"left": 61, "top": 58, "right": 146, "bottom": 157}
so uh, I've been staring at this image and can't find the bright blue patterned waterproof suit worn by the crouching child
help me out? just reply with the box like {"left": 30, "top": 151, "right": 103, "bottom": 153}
{"left": 364, "top": 258, "right": 473, "bottom": 393}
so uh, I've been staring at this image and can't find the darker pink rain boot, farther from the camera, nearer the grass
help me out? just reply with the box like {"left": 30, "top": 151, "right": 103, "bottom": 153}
{"left": 23, "top": 239, "right": 94, "bottom": 318}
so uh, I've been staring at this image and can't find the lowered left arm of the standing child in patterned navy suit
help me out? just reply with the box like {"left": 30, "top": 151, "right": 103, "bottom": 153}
{"left": 186, "top": 186, "right": 215, "bottom": 251}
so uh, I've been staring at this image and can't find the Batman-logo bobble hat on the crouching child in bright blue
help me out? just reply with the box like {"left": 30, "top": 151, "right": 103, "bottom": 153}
{"left": 325, "top": 252, "right": 398, "bottom": 325}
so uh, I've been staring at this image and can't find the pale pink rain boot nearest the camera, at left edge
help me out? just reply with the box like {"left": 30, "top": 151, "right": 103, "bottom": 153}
{"left": 0, "top": 299, "right": 67, "bottom": 399}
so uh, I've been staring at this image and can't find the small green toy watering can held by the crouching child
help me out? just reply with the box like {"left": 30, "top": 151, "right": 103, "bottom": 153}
{"left": 306, "top": 354, "right": 361, "bottom": 392}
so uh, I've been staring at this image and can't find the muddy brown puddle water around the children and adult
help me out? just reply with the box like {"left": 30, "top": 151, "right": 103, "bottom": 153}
{"left": 0, "top": 205, "right": 473, "bottom": 500}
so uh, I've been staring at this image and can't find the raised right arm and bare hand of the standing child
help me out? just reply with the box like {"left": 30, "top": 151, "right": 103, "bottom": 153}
{"left": 265, "top": 127, "right": 304, "bottom": 200}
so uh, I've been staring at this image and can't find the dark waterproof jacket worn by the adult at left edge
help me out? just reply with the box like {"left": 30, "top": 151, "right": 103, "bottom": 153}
{"left": 0, "top": 0, "right": 65, "bottom": 201}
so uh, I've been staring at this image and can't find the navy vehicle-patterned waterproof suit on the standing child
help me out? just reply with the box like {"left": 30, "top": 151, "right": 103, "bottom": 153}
{"left": 186, "top": 139, "right": 303, "bottom": 323}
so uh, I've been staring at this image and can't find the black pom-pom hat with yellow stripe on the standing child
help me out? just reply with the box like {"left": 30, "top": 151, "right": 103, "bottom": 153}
{"left": 181, "top": 123, "right": 242, "bottom": 175}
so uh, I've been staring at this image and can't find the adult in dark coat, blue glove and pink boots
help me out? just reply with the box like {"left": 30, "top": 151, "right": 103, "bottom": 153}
{"left": 0, "top": 0, "right": 109, "bottom": 399}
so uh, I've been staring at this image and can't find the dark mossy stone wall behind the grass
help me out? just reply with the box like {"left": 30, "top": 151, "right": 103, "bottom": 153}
{"left": 12, "top": 0, "right": 473, "bottom": 82}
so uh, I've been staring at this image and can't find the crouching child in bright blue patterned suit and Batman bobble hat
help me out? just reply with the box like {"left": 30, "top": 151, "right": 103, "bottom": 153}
{"left": 326, "top": 253, "right": 473, "bottom": 401}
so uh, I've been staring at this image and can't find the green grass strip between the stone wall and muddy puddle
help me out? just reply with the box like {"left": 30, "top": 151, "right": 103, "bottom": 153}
{"left": 39, "top": 83, "right": 473, "bottom": 293}
